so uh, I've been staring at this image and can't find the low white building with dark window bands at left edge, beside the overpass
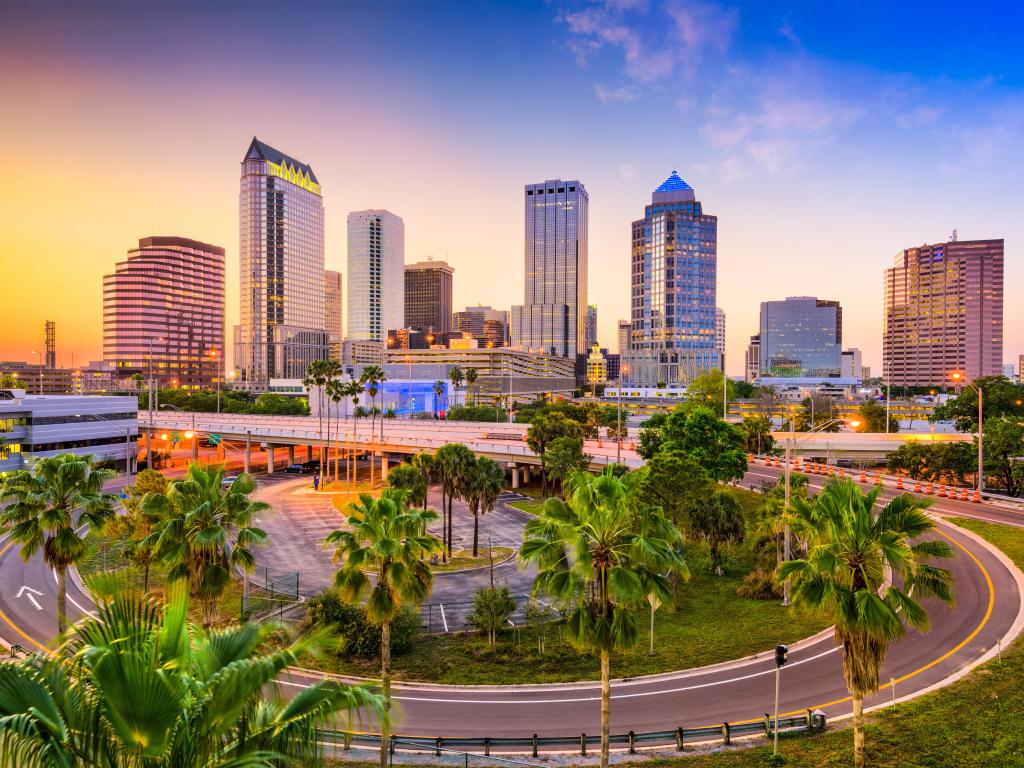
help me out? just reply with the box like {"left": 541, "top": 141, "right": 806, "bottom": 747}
{"left": 0, "top": 389, "right": 138, "bottom": 473}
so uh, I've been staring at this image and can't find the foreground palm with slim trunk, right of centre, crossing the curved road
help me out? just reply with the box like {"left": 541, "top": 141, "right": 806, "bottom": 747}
{"left": 520, "top": 472, "right": 688, "bottom": 768}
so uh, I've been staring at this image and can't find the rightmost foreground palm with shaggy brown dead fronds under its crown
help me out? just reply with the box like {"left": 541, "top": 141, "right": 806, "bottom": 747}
{"left": 779, "top": 478, "right": 953, "bottom": 768}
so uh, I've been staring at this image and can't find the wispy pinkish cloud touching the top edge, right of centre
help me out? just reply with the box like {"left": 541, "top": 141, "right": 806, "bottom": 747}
{"left": 559, "top": 0, "right": 738, "bottom": 84}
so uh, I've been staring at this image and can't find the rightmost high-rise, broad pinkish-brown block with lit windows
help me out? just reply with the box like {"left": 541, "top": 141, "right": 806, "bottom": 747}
{"left": 882, "top": 239, "right": 1002, "bottom": 387}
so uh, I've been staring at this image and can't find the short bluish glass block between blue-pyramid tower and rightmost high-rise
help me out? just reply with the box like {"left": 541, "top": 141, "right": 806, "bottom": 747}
{"left": 760, "top": 296, "right": 843, "bottom": 379}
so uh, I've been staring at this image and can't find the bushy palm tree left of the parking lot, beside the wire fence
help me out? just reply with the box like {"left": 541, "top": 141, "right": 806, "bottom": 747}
{"left": 142, "top": 464, "right": 270, "bottom": 626}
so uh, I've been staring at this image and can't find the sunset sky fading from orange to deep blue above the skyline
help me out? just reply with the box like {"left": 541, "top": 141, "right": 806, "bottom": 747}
{"left": 0, "top": 0, "right": 1024, "bottom": 375}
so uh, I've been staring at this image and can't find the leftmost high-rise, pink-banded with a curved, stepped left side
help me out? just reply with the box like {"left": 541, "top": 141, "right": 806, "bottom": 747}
{"left": 103, "top": 237, "right": 224, "bottom": 388}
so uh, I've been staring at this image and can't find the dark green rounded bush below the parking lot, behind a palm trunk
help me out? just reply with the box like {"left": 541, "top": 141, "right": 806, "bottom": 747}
{"left": 306, "top": 590, "right": 420, "bottom": 658}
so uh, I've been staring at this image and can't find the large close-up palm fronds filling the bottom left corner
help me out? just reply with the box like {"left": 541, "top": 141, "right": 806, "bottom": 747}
{"left": 0, "top": 587, "right": 386, "bottom": 768}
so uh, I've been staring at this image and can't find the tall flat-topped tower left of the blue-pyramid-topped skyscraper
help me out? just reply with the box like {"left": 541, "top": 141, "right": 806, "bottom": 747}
{"left": 512, "top": 179, "right": 589, "bottom": 359}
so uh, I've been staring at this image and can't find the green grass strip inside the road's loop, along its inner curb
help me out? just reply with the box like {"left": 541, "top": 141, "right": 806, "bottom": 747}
{"left": 299, "top": 547, "right": 827, "bottom": 685}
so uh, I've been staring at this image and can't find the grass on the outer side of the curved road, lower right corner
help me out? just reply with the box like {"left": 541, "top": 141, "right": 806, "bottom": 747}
{"left": 585, "top": 519, "right": 1024, "bottom": 768}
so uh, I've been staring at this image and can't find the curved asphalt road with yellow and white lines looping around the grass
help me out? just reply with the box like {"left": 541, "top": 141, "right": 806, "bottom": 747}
{"left": 0, "top": 466, "right": 1024, "bottom": 753}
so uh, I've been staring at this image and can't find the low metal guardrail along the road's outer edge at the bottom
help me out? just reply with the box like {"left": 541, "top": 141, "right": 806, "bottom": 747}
{"left": 317, "top": 710, "right": 826, "bottom": 765}
